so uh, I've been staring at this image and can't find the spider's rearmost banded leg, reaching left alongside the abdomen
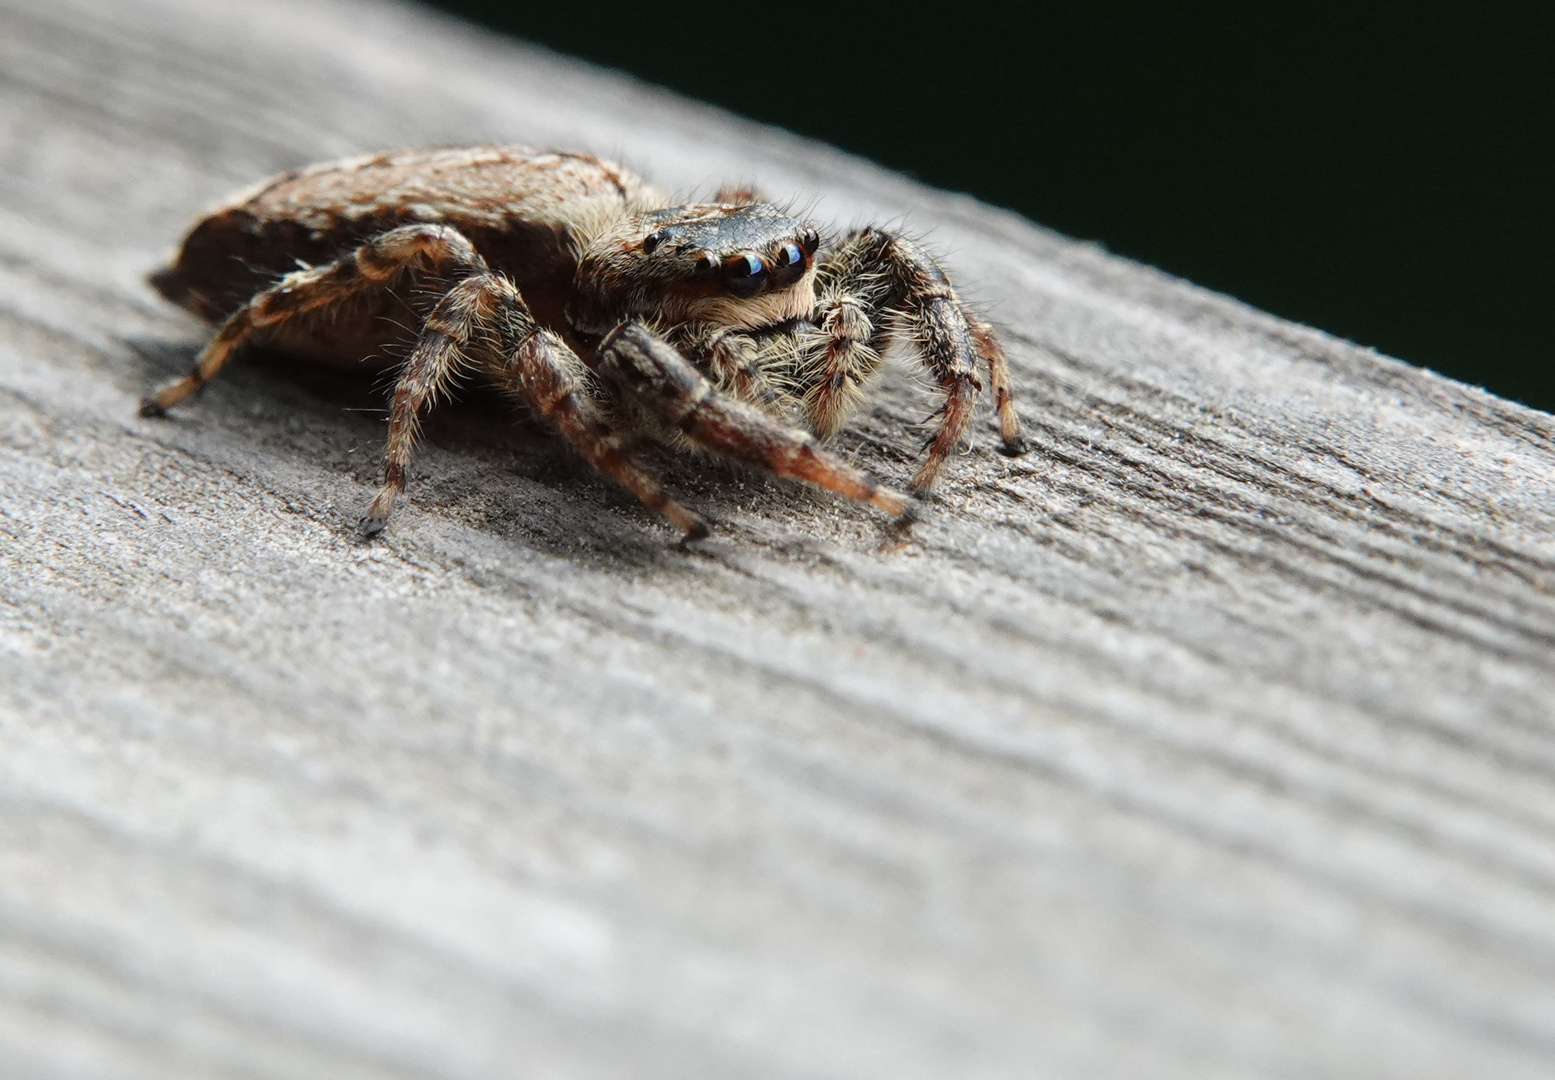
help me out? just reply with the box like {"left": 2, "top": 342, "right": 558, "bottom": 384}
{"left": 140, "top": 225, "right": 485, "bottom": 416}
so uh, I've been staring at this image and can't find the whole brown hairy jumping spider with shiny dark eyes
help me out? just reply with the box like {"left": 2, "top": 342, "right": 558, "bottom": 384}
{"left": 140, "top": 146, "right": 1026, "bottom": 539}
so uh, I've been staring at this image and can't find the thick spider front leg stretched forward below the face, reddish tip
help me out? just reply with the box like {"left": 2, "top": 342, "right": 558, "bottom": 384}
{"left": 599, "top": 323, "right": 913, "bottom": 517}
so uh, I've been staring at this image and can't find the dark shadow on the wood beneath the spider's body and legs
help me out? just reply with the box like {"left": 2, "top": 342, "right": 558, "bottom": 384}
{"left": 120, "top": 337, "right": 889, "bottom": 569}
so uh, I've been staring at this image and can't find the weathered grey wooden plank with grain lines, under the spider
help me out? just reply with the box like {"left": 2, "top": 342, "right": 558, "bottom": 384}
{"left": 0, "top": 0, "right": 1555, "bottom": 1080}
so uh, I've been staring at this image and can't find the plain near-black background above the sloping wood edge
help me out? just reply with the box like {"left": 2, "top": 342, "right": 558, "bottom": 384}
{"left": 419, "top": 0, "right": 1555, "bottom": 410}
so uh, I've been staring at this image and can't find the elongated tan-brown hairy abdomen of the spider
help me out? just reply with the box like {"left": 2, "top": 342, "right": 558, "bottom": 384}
{"left": 151, "top": 148, "right": 664, "bottom": 367}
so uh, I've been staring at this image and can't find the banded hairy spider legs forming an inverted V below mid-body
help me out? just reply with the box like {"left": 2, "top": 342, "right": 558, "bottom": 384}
{"left": 361, "top": 270, "right": 708, "bottom": 539}
